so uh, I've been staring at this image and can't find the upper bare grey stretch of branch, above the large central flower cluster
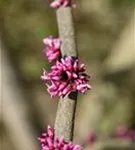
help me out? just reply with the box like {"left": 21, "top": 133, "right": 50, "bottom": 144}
{"left": 57, "top": 7, "right": 78, "bottom": 57}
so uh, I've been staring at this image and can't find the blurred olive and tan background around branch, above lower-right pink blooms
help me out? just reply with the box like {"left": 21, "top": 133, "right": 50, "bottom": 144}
{"left": 0, "top": 0, "right": 135, "bottom": 150}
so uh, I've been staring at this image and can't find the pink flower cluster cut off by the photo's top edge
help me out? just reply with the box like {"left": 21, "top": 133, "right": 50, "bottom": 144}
{"left": 50, "top": 0, "right": 74, "bottom": 8}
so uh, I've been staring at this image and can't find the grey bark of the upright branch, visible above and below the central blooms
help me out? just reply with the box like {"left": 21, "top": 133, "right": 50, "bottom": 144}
{"left": 55, "top": 7, "right": 77, "bottom": 141}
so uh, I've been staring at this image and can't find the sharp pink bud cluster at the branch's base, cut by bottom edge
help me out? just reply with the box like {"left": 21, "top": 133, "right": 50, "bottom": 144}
{"left": 38, "top": 127, "right": 82, "bottom": 150}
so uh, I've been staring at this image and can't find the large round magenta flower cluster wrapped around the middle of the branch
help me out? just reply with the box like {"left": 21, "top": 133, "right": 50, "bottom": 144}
{"left": 41, "top": 57, "right": 91, "bottom": 97}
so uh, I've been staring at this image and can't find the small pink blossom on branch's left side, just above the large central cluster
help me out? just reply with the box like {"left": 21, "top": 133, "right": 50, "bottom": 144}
{"left": 43, "top": 36, "right": 61, "bottom": 62}
